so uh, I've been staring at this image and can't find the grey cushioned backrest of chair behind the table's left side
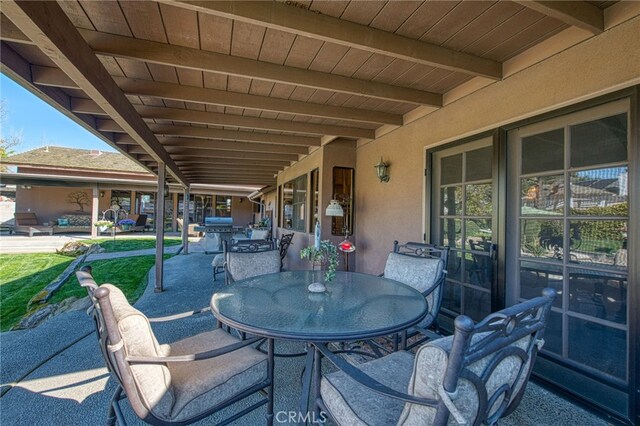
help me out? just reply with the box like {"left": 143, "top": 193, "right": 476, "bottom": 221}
{"left": 223, "top": 240, "right": 280, "bottom": 284}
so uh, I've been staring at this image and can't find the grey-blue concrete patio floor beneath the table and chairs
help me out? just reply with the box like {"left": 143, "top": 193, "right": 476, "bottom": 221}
{"left": 0, "top": 251, "right": 609, "bottom": 426}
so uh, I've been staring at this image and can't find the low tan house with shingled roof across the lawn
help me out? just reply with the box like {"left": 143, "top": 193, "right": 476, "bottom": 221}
{"left": 2, "top": 146, "right": 255, "bottom": 232}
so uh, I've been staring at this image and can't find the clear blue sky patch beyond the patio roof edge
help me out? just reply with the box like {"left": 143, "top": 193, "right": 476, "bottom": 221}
{"left": 0, "top": 74, "right": 115, "bottom": 153}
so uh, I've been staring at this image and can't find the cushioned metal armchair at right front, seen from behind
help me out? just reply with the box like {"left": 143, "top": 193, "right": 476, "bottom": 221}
{"left": 314, "top": 288, "right": 555, "bottom": 426}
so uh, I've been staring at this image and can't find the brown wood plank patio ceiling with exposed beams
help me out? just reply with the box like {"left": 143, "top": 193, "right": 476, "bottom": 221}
{"left": 0, "top": 1, "right": 615, "bottom": 186}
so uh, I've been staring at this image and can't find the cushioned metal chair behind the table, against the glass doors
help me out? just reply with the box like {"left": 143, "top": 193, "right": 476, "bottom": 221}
{"left": 369, "top": 241, "right": 449, "bottom": 354}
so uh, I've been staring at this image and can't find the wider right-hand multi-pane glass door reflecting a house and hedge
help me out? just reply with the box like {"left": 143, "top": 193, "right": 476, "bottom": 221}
{"left": 507, "top": 102, "right": 629, "bottom": 420}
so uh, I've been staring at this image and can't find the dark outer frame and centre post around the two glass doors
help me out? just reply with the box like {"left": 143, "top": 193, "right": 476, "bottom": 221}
{"left": 422, "top": 85, "right": 640, "bottom": 424}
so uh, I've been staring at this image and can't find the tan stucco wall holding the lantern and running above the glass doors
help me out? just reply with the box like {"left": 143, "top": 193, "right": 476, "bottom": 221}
{"left": 355, "top": 17, "right": 640, "bottom": 273}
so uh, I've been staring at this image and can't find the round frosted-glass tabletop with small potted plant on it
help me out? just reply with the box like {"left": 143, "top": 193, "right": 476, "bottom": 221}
{"left": 211, "top": 271, "right": 427, "bottom": 342}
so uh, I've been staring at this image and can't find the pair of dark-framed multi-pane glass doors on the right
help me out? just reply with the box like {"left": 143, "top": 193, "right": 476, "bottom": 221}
{"left": 426, "top": 98, "right": 640, "bottom": 419}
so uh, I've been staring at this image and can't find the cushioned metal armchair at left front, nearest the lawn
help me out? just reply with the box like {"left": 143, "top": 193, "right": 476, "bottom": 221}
{"left": 76, "top": 269, "right": 273, "bottom": 425}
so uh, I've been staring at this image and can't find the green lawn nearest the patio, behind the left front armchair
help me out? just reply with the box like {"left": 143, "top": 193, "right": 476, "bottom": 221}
{"left": 0, "top": 253, "right": 171, "bottom": 331}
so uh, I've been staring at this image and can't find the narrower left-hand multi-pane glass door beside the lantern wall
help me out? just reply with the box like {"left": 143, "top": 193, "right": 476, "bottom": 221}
{"left": 431, "top": 137, "right": 497, "bottom": 320}
